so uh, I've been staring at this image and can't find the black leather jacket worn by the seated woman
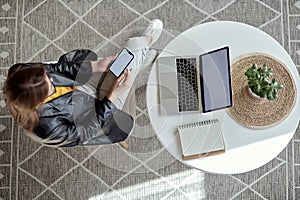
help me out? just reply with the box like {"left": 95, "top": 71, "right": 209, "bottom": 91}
{"left": 11, "top": 50, "right": 133, "bottom": 147}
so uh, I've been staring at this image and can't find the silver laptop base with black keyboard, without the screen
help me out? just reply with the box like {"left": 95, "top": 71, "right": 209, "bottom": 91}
{"left": 157, "top": 56, "right": 202, "bottom": 115}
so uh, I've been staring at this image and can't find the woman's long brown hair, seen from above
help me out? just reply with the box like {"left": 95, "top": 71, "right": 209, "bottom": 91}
{"left": 3, "top": 64, "right": 49, "bottom": 132}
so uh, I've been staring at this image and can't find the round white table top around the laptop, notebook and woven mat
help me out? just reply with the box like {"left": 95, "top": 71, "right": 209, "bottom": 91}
{"left": 147, "top": 21, "right": 300, "bottom": 174}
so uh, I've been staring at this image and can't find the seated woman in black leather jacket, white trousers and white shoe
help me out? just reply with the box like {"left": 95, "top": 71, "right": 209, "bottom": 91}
{"left": 3, "top": 19, "right": 163, "bottom": 147}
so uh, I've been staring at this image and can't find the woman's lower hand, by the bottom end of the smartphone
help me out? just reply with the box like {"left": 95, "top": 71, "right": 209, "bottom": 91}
{"left": 107, "top": 69, "right": 131, "bottom": 102}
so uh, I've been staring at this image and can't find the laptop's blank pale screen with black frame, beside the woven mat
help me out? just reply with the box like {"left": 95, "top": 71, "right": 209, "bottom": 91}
{"left": 200, "top": 47, "right": 232, "bottom": 112}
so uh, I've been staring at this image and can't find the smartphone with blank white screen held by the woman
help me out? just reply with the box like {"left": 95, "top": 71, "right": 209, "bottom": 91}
{"left": 109, "top": 48, "right": 134, "bottom": 78}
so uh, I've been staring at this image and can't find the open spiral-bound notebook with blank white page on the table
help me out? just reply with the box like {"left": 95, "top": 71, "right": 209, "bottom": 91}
{"left": 178, "top": 119, "right": 225, "bottom": 160}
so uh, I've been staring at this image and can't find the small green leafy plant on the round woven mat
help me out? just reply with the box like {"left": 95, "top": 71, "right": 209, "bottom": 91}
{"left": 245, "top": 64, "right": 283, "bottom": 100}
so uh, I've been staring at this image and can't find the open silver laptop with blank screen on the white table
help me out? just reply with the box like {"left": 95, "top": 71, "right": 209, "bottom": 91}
{"left": 157, "top": 46, "right": 233, "bottom": 115}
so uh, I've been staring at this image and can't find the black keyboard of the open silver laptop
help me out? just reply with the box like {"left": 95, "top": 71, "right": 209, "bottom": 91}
{"left": 176, "top": 58, "right": 199, "bottom": 112}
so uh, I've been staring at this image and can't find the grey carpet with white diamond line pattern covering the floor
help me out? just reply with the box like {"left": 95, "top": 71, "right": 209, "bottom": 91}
{"left": 0, "top": 0, "right": 300, "bottom": 200}
